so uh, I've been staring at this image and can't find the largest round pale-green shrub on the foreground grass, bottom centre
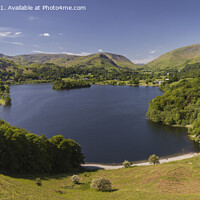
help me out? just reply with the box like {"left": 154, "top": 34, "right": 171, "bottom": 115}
{"left": 90, "top": 178, "right": 112, "bottom": 192}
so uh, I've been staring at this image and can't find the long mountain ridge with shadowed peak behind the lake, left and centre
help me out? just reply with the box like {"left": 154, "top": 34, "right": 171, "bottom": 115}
{"left": 0, "top": 53, "right": 140, "bottom": 69}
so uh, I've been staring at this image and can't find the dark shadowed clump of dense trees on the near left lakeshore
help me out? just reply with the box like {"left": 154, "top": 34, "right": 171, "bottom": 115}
{"left": 0, "top": 120, "right": 84, "bottom": 174}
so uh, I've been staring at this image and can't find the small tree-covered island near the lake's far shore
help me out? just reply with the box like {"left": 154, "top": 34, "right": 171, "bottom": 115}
{"left": 53, "top": 79, "right": 91, "bottom": 90}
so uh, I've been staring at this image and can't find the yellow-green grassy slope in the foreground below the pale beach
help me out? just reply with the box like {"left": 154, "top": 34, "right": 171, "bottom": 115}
{"left": 0, "top": 156, "right": 200, "bottom": 200}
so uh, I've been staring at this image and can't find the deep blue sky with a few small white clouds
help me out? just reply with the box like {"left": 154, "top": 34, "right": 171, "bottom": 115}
{"left": 0, "top": 0, "right": 200, "bottom": 63}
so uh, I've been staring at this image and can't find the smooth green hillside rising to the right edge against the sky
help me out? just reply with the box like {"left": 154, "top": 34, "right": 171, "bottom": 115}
{"left": 147, "top": 44, "right": 200, "bottom": 70}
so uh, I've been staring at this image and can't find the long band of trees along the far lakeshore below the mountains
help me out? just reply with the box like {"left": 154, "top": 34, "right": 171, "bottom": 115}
{"left": 0, "top": 61, "right": 160, "bottom": 84}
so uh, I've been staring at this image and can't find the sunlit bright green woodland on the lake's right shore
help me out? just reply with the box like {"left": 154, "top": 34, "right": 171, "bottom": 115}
{"left": 147, "top": 78, "right": 200, "bottom": 142}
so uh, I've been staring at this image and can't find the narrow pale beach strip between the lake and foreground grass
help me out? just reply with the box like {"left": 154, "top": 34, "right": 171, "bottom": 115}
{"left": 81, "top": 152, "right": 200, "bottom": 170}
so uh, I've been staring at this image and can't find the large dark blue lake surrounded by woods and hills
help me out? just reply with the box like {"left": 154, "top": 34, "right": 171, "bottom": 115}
{"left": 0, "top": 84, "right": 199, "bottom": 163}
